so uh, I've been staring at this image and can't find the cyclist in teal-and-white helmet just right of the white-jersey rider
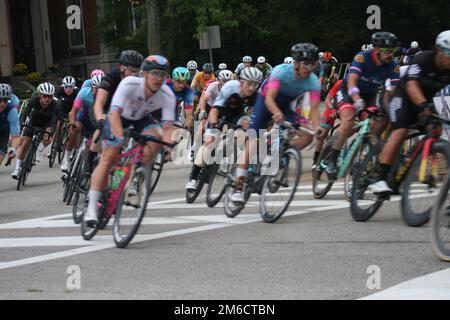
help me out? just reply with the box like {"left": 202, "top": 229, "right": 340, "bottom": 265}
{"left": 166, "top": 67, "right": 194, "bottom": 128}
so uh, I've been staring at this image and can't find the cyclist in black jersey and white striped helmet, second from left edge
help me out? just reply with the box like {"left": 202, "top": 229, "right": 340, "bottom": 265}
{"left": 12, "top": 82, "right": 58, "bottom": 179}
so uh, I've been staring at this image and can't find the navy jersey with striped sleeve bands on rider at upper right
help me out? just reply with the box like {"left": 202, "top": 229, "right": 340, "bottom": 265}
{"left": 344, "top": 50, "right": 400, "bottom": 95}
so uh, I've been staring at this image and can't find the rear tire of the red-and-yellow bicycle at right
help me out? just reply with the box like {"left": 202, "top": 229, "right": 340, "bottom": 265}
{"left": 350, "top": 144, "right": 384, "bottom": 222}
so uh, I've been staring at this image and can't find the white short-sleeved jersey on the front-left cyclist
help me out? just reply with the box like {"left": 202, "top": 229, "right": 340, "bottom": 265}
{"left": 110, "top": 76, "right": 177, "bottom": 121}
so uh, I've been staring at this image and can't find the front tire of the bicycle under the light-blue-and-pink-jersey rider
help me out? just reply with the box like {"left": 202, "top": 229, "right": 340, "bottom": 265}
{"left": 259, "top": 148, "right": 302, "bottom": 223}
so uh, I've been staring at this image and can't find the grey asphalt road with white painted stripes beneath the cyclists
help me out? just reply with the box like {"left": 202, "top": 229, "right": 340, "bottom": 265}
{"left": 0, "top": 152, "right": 450, "bottom": 300}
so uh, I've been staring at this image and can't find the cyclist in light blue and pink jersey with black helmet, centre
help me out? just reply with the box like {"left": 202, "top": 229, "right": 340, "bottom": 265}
{"left": 230, "top": 43, "right": 320, "bottom": 203}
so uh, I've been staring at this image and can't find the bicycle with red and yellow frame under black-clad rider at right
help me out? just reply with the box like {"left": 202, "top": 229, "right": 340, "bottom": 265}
{"left": 350, "top": 116, "right": 450, "bottom": 227}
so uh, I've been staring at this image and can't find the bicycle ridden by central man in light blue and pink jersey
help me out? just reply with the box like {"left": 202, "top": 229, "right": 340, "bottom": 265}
{"left": 224, "top": 122, "right": 314, "bottom": 223}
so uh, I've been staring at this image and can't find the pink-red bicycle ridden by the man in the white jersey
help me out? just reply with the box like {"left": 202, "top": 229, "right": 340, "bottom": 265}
{"left": 81, "top": 129, "right": 175, "bottom": 248}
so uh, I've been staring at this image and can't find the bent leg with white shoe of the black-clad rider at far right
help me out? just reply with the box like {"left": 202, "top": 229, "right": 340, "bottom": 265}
{"left": 369, "top": 92, "right": 418, "bottom": 193}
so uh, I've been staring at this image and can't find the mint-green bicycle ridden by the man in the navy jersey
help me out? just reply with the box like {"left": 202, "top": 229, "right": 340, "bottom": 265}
{"left": 312, "top": 110, "right": 386, "bottom": 201}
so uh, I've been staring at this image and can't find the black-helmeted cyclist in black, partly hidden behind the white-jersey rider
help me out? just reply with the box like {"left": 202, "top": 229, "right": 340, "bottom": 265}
{"left": 94, "top": 50, "right": 144, "bottom": 140}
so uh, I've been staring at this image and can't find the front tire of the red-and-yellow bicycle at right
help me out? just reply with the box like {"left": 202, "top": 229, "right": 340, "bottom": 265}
{"left": 400, "top": 141, "right": 450, "bottom": 227}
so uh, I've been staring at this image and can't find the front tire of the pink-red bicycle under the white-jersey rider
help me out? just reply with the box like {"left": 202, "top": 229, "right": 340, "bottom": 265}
{"left": 112, "top": 170, "right": 152, "bottom": 249}
